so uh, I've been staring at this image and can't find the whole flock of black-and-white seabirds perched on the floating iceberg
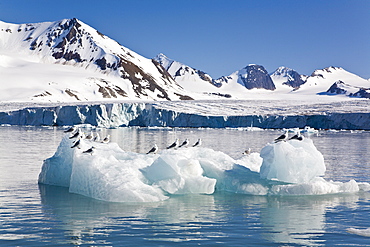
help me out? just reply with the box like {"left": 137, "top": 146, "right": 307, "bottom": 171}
{"left": 64, "top": 126, "right": 303, "bottom": 155}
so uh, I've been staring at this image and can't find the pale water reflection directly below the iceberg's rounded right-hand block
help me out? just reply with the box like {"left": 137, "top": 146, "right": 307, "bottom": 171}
{"left": 261, "top": 194, "right": 359, "bottom": 246}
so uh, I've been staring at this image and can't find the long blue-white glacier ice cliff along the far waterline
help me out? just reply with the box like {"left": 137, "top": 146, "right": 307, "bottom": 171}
{"left": 0, "top": 102, "right": 370, "bottom": 130}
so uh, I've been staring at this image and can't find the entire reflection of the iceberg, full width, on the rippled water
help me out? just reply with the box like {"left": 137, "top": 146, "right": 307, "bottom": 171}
{"left": 39, "top": 185, "right": 359, "bottom": 246}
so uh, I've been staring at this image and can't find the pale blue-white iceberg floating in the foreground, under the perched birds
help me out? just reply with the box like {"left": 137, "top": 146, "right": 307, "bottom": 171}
{"left": 39, "top": 135, "right": 370, "bottom": 202}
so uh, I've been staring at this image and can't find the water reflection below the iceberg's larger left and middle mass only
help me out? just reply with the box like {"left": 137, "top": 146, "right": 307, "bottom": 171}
{"left": 39, "top": 185, "right": 218, "bottom": 245}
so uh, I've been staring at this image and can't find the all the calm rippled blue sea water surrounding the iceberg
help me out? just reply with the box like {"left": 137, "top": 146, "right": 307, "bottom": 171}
{"left": 0, "top": 127, "right": 370, "bottom": 246}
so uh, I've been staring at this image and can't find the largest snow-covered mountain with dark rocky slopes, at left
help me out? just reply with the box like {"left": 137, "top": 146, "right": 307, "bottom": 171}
{"left": 0, "top": 19, "right": 192, "bottom": 101}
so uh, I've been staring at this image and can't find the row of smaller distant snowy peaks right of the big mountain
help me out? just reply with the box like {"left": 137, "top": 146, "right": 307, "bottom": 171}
{"left": 155, "top": 54, "right": 370, "bottom": 99}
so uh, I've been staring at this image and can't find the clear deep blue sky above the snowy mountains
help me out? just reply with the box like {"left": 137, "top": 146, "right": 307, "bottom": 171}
{"left": 0, "top": 0, "right": 370, "bottom": 78}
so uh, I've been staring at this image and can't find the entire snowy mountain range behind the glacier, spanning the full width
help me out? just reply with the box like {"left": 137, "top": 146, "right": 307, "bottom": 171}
{"left": 0, "top": 18, "right": 370, "bottom": 102}
